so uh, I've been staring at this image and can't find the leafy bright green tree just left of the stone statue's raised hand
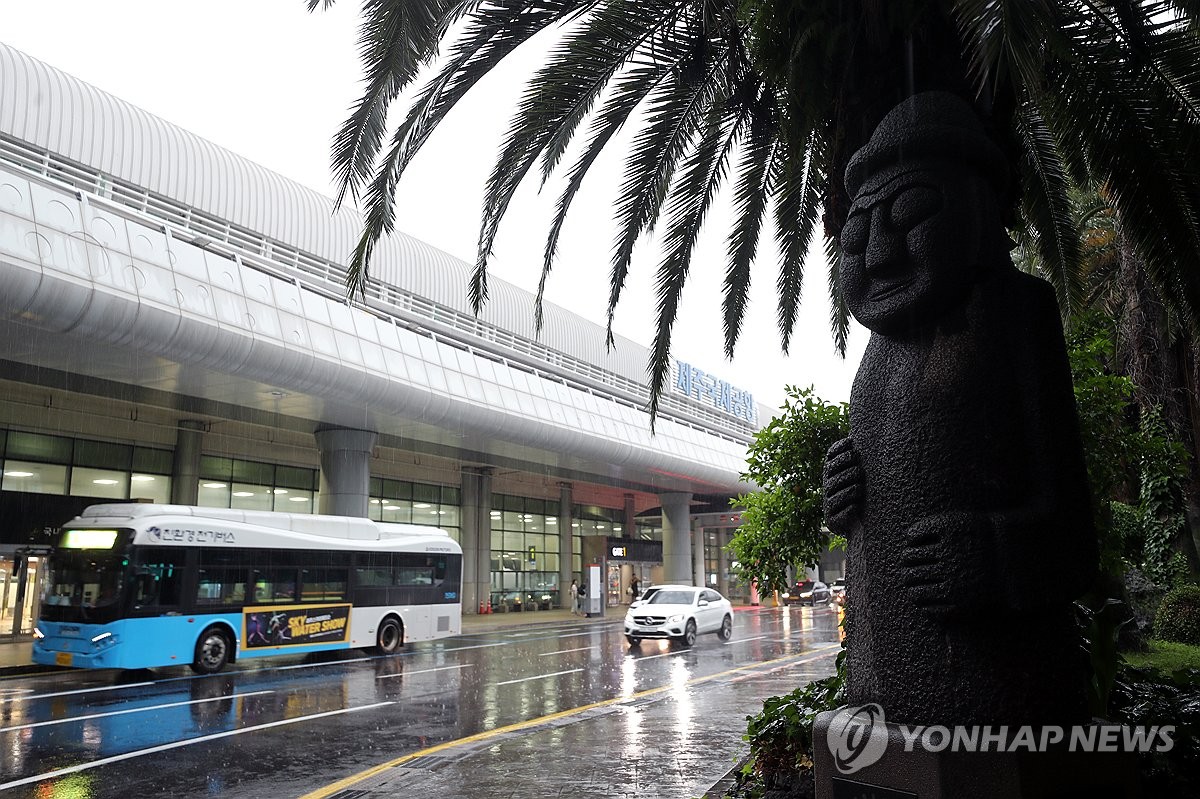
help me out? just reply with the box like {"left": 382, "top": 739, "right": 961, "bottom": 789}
{"left": 730, "top": 386, "right": 850, "bottom": 591}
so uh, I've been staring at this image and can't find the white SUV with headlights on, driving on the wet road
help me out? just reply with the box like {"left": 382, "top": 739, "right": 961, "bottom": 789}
{"left": 625, "top": 585, "right": 733, "bottom": 647}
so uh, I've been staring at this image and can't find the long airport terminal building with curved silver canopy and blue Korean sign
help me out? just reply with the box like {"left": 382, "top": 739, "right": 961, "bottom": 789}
{"left": 0, "top": 43, "right": 772, "bottom": 635}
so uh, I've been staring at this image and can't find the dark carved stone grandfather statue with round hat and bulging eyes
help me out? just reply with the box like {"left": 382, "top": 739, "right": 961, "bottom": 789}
{"left": 824, "top": 92, "right": 1097, "bottom": 725}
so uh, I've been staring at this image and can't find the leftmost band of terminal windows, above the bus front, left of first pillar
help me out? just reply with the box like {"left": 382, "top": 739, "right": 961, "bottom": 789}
{"left": 0, "top": 431, "right": 172, "bottom": 503}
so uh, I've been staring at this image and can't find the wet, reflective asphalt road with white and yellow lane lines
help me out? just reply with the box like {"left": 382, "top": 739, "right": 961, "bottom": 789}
{"left": 0, "top": 608, "right": 838, "bottom": 799}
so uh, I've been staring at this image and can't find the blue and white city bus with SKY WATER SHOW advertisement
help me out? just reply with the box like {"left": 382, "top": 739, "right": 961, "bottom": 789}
{"left": 34, "top": 503, "right": 462, "bottom": 674}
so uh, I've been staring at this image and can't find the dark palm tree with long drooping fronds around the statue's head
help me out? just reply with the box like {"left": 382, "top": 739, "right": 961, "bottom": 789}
{"left": 306, "top": 0, "right": 1200, "bottom": 414}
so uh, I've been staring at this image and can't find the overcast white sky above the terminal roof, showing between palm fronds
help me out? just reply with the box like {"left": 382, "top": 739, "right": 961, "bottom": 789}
{"left": 0, "top": 0, "right": 866, "bottom": 410}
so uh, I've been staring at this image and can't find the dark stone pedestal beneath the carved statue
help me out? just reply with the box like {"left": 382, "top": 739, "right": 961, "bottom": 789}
{"left": 812, "top": 711, "right": 1141, "bottom": 799}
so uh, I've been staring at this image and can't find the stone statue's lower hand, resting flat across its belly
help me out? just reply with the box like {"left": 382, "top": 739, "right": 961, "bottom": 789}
{"left": 900, "top": 513, "right": 995, "bottom": 618}
